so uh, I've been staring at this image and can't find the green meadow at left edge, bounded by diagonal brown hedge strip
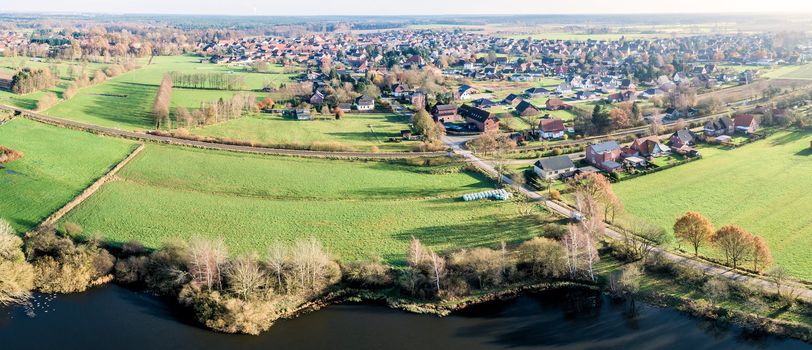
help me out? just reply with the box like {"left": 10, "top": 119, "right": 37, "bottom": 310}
{"left": 0, "top": 118, "right": 133, "bottom": 231}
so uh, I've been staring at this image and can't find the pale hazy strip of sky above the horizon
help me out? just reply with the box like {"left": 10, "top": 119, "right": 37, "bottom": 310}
{"left": 0, "top": 0, "right": 812, "bottom": 15}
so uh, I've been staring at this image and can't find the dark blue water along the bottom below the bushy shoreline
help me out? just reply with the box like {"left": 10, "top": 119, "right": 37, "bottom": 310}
{"left": 0, "top": 286, "right": 810, "bottom": 350}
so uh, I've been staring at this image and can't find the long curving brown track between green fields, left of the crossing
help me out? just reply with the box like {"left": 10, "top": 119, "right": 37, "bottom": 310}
{"left": 0, "top": 105, "right": 448, "bottom": 159}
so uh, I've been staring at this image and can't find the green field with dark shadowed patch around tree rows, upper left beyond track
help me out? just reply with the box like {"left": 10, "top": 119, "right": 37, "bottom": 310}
{"left": 42, "top": 56, "right": 292, "bottom": 130}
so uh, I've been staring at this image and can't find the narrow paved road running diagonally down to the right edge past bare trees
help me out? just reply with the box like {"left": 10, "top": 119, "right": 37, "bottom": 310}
{"left": 446, "top": 135, "right": 812, "bottom": 301}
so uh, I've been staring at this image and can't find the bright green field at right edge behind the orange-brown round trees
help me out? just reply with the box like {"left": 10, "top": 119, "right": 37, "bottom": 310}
{"left": 614, "top": 132, "right": 812, "bottom": 280}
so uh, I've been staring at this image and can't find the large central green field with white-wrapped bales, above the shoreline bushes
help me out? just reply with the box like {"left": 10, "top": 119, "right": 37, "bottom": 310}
{"left": 64, "top": 145, "right": 539, "bottom": 262}
